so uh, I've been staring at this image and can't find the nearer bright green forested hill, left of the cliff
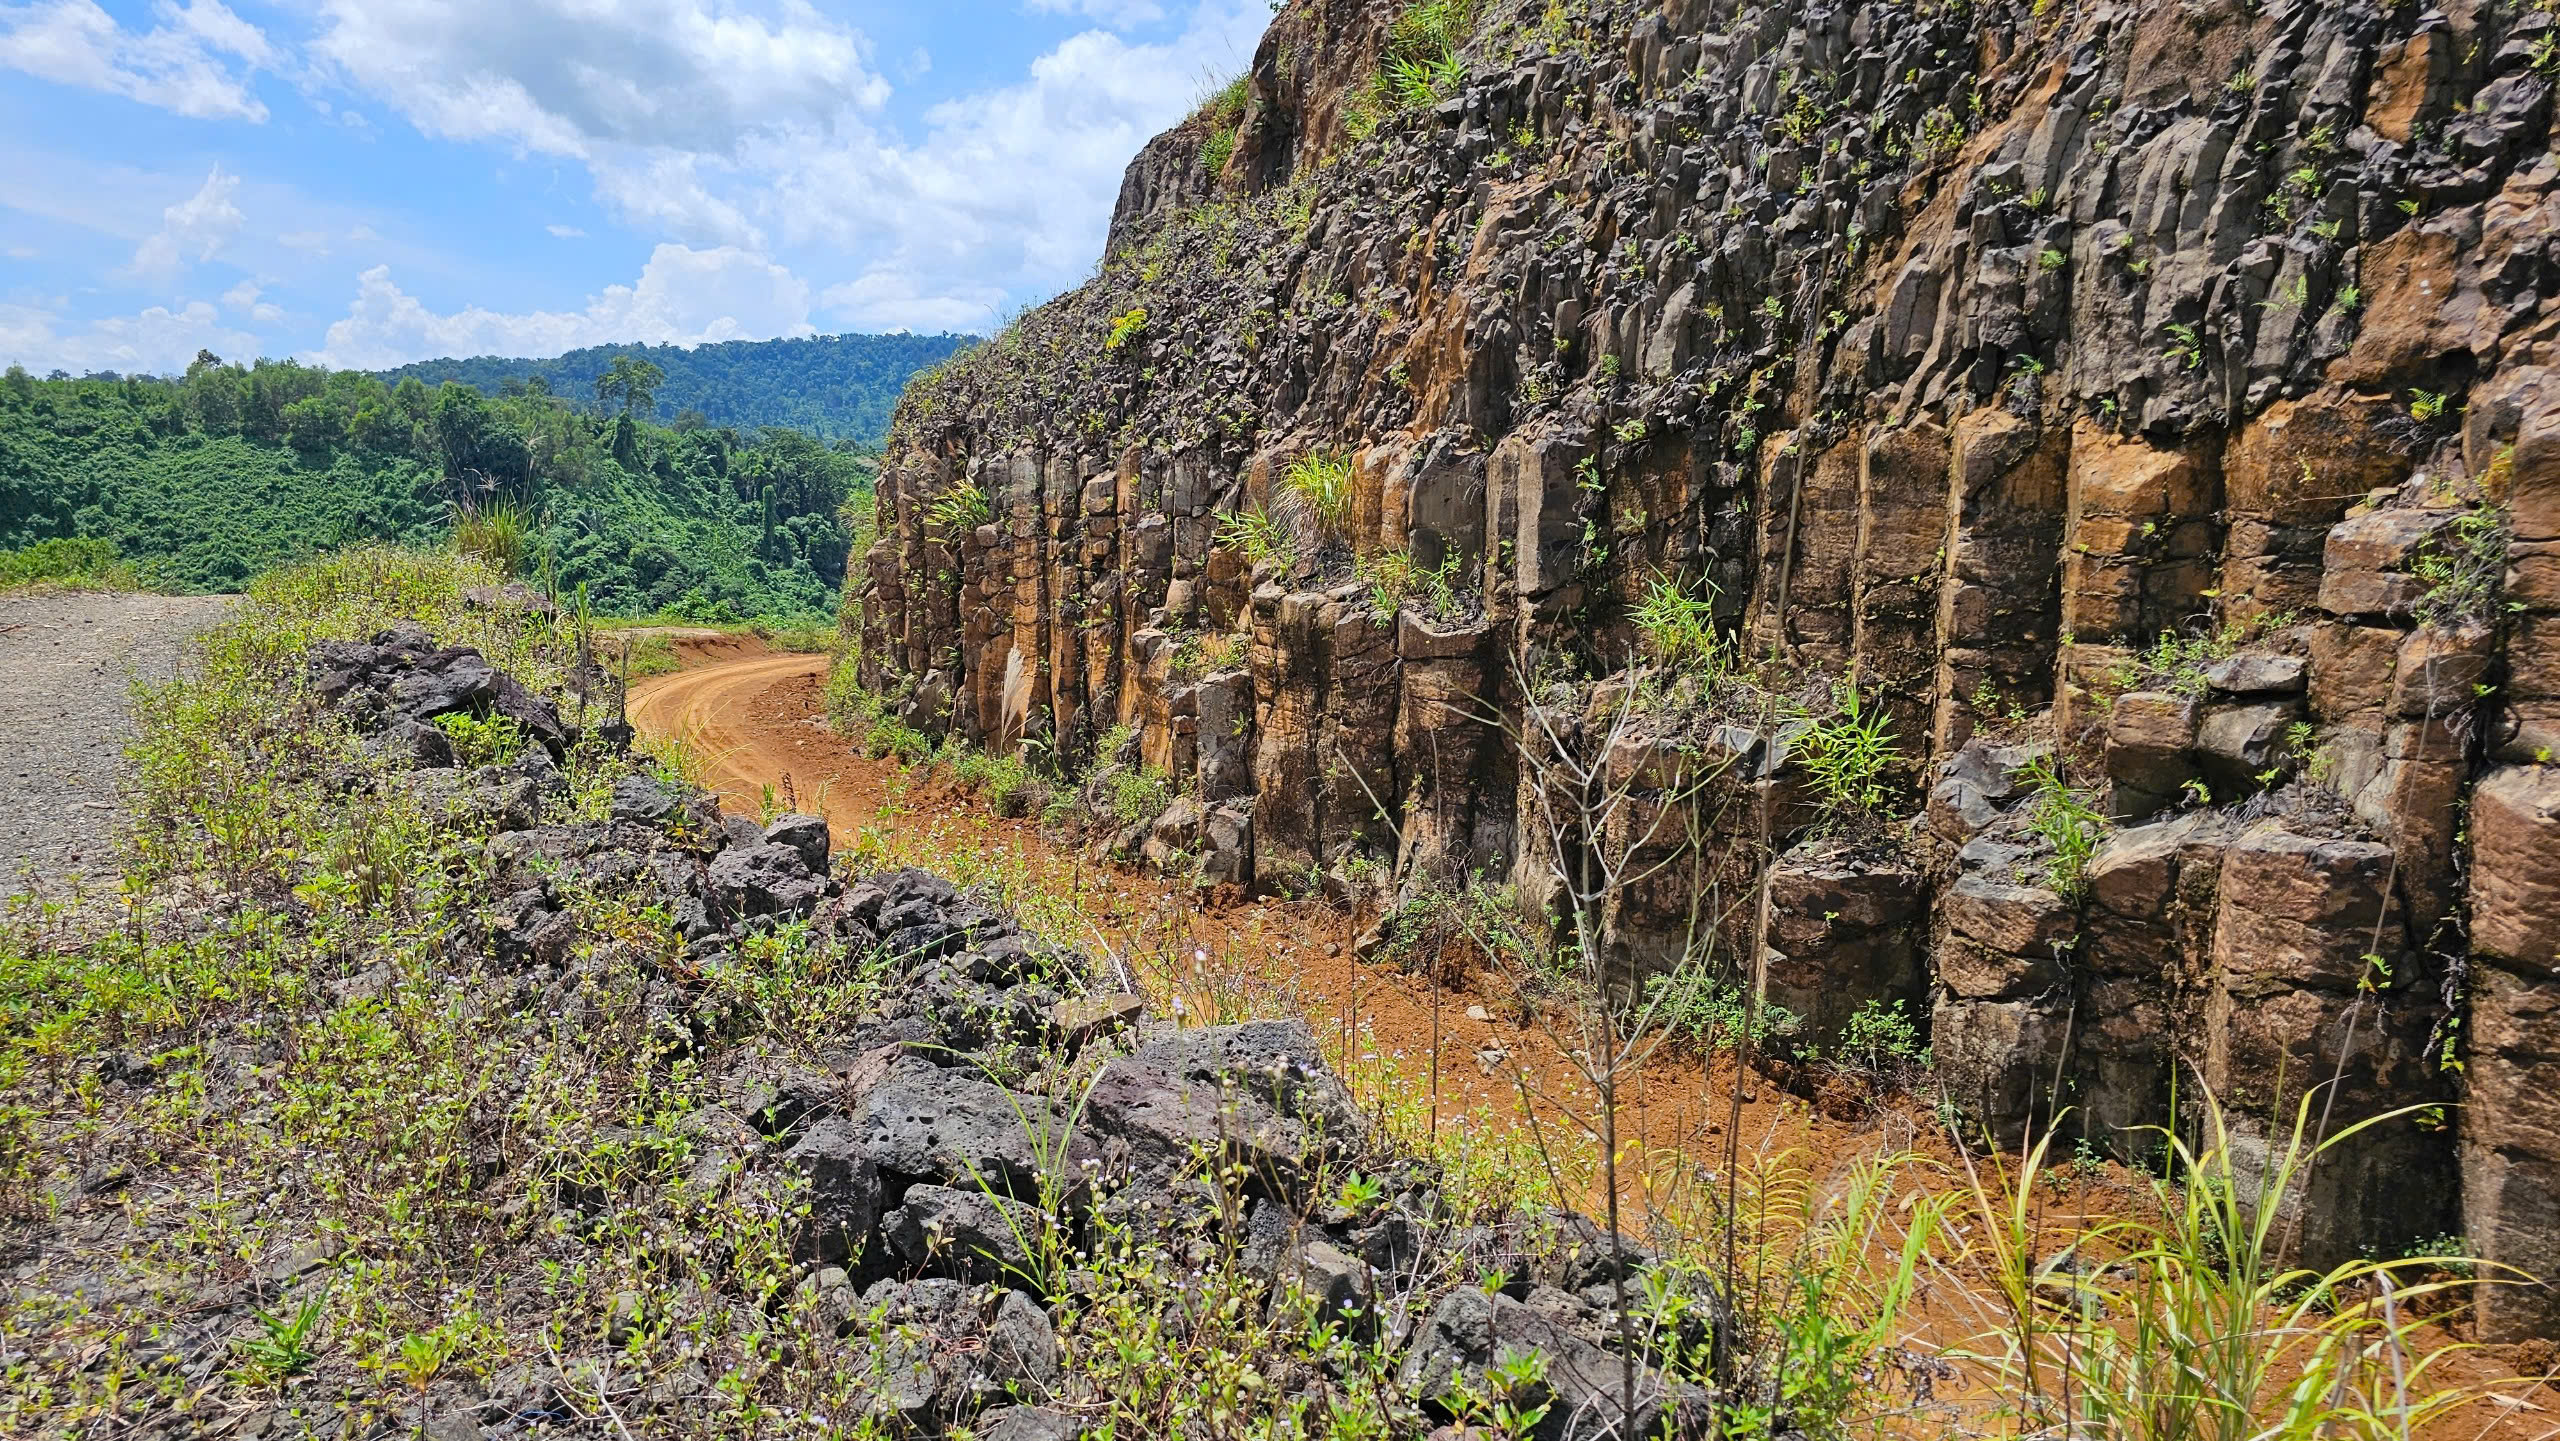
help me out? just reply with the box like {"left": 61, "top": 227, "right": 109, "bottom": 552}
{"left": 0, "top": 356, "right": 873, "bottom": 619}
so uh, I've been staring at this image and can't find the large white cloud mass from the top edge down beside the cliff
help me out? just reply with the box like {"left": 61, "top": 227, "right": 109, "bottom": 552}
{"left": 312, "top": 0, "right": 1270, "bottom": 328}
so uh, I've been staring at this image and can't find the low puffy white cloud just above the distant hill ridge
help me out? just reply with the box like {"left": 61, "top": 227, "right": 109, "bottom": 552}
{"left": 315, "top": 246, "right": 814, "bottom": 371}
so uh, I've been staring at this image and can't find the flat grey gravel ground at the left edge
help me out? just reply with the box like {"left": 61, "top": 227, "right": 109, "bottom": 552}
{"left": 0, "top": 591, "right": 230, "bottom": 896}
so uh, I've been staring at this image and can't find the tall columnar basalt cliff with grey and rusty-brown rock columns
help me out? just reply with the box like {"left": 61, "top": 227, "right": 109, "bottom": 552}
{"left": 855, "top": 0, "right": 2560, "bottom": 1339}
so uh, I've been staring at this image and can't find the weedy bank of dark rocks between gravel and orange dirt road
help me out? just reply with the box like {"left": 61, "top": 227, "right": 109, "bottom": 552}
{"left": 8, "top": 627, "right": 1715, "bottom": 1441}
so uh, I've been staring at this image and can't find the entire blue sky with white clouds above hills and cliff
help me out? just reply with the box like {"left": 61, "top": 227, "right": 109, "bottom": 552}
{"left": 0, "top": 0, "right": 1270, "bottom": 374}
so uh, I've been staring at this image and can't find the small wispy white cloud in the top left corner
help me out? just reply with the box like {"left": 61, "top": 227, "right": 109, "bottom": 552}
{"left": 0, "top": 0, "right": 274, "bottom": 120}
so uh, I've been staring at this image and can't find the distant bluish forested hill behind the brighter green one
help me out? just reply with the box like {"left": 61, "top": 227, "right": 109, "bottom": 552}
{"left": 381, "top": 335, "right": 975, "bottom": 445}
